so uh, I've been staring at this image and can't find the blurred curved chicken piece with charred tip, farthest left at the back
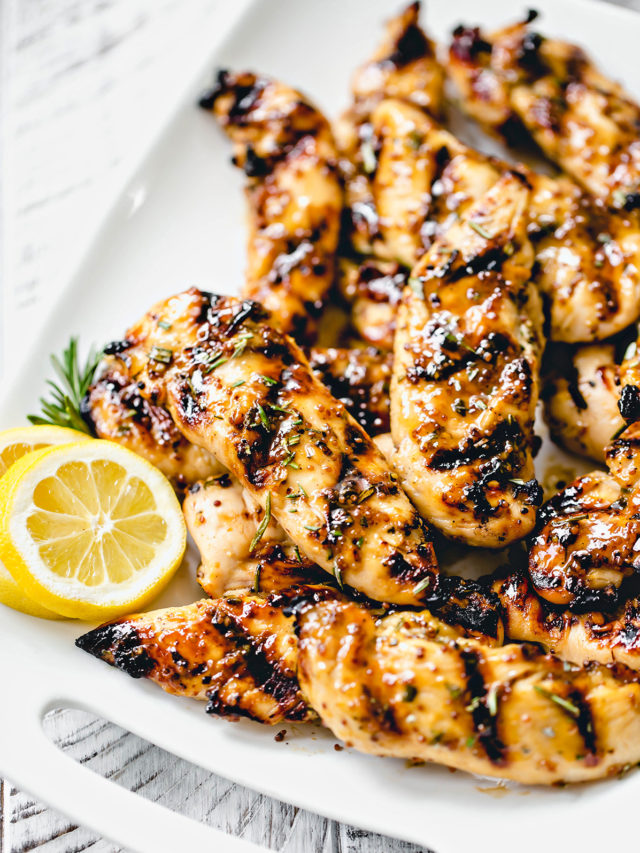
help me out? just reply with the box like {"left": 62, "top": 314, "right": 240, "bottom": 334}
{"left": 200, "top": 71, "right": 342, "bottom": 340}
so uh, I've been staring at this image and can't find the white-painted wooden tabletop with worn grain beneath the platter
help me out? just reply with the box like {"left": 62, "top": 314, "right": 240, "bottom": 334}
{"left": 0, "top": 0, "right": 640, "bottom": 853}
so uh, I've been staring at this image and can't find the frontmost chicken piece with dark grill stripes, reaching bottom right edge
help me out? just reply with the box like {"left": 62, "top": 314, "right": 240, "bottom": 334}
{"left": 298, "top": 601, "right": 640, "bottom": 784}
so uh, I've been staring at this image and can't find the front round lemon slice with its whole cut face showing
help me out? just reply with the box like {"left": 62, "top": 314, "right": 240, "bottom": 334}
{"left": 0, "top": 441, "right": 186, "bottom": 619}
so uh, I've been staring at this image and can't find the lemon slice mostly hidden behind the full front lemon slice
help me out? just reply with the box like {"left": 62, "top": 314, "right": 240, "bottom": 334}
{"left": 0, "top": 426, "right": 89, "bottom": 619}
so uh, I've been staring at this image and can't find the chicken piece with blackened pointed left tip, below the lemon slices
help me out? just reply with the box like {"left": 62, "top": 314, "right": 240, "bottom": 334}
{"left": 76, "top": 565, "right": 335, "bottom": 725}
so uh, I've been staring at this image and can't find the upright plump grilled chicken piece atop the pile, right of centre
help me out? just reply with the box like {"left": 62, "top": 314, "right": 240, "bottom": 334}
{"left": 391, "top": 172, "right": 541, "bottom": 548}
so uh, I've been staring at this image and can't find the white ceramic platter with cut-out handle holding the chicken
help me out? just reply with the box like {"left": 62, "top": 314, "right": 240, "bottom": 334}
{"left": 0, "top": 0, "right": 640, "bottom": 853}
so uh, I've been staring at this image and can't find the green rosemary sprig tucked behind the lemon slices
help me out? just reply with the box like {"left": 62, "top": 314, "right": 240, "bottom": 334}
{"left": 27, "top": 338, "right": 103, "bottom": 435}
